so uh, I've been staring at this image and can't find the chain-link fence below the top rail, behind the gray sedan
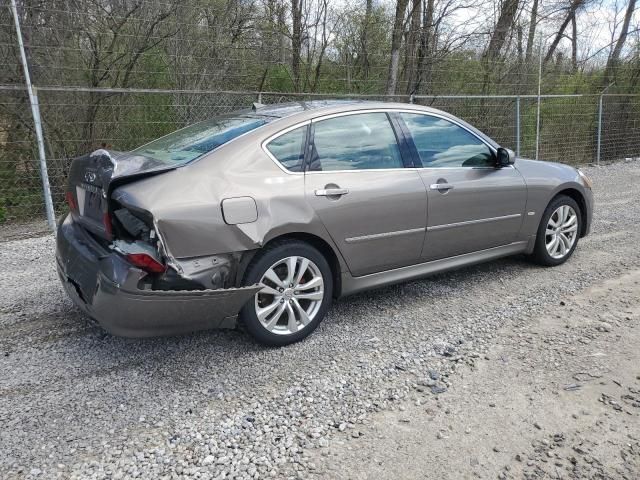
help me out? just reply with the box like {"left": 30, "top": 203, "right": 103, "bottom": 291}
{"left": 0, "top": 86, "right": 640, "bottom": 228}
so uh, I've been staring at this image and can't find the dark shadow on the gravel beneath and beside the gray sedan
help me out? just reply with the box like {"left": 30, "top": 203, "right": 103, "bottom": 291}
{"left": 12, "top": 253, "right": 539, "bottom": 396}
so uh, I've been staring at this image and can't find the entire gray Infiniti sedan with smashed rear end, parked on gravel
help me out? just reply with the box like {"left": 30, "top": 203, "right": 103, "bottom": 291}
{"left": 56, "top": 101, "right": 593, "bottom": 345}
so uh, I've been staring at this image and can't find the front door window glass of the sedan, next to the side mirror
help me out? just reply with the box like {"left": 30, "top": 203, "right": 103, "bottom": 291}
{"left": 400, "top": 113, "right": 495, "bottom": 168}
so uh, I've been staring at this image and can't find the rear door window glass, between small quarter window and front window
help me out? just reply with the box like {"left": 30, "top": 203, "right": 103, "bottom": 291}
{"left": 309, "top": 113, "right": 403, "bottom": 171}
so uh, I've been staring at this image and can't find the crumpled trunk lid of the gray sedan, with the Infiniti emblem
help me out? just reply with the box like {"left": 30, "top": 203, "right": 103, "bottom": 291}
{"left": 67, "top": 150, "right": 177, "bottom": 240}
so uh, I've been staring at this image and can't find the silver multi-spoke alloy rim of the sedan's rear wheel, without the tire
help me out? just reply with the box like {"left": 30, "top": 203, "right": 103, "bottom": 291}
{"left": 255, "top": 256, "right": 324, "bottom": 335}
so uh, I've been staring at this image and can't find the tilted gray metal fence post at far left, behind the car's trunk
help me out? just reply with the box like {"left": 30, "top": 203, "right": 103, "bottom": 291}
{"left": 11, "top": 0, "right": 56, "bottom": 235}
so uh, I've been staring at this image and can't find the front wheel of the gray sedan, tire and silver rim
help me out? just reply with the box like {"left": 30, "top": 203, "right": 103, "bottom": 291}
{"left": 533, "top": 195, "right": 582, "bottom": 266}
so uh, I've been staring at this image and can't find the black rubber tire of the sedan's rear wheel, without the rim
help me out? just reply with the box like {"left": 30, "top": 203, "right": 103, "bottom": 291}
{"left": 238, "top": 240, "right": 333, "bottom": 347}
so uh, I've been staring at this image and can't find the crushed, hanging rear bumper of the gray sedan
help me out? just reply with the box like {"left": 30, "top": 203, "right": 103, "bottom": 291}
{"left": 56, "top": 217, "right": 260, "bottom": 337}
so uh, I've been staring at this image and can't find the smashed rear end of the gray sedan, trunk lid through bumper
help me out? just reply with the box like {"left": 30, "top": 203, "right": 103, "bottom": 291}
{"left": 57, "top": 146, "right": 259, "bottom": 336}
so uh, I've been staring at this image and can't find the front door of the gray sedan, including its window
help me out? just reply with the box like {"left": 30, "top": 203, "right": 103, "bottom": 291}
{"left": 398, "top": 113, "right": 527, "bottom": 261}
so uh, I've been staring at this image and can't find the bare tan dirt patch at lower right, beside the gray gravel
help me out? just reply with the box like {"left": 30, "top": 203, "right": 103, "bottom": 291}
{"left": 316, "top": 270, "right": 640, "bottom": 480}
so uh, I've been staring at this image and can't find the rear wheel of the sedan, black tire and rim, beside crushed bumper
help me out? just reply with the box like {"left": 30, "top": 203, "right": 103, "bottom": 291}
{"left": 240, "top": 240, "right": 333, "bottom": 346}
